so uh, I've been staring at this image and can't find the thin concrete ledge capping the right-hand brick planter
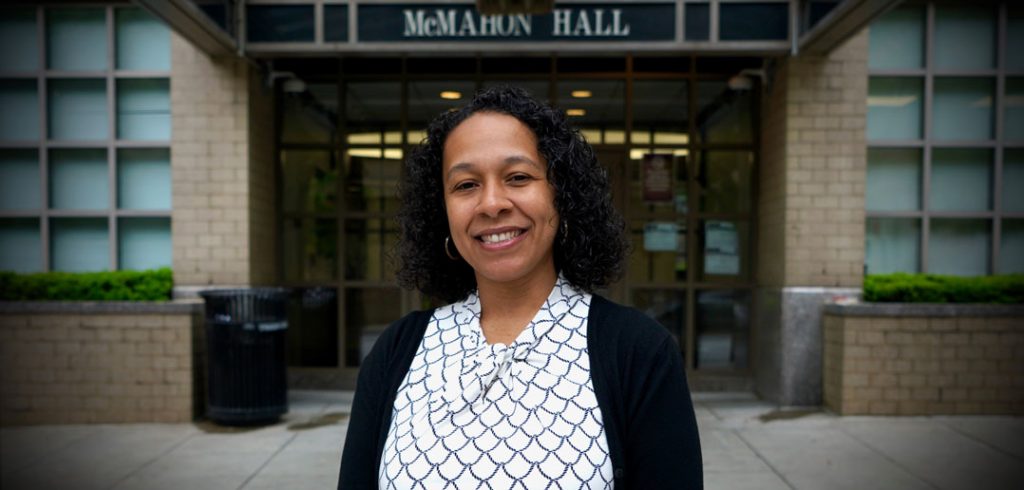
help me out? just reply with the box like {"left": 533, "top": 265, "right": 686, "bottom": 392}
{"left": 824, "top": 303, "right": 1024, "bottom": 318}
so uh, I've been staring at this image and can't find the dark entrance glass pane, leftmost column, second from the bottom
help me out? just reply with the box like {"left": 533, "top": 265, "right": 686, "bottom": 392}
{"left": 284, "top": 218, "right": 338, "bottom": 281}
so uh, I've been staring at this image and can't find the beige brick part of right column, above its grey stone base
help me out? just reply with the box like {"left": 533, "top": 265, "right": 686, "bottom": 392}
{"left": 758, "top": 30, "right": 867, "bottom": 287}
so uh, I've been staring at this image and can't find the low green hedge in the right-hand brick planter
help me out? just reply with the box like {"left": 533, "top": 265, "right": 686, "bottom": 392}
{"left": 864, "top": 273, "right": 1024, "bottom": 304}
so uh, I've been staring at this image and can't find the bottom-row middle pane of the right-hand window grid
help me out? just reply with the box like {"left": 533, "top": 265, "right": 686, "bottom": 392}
{"left": 928, "top": 218, "right": 992, "bottom": 276}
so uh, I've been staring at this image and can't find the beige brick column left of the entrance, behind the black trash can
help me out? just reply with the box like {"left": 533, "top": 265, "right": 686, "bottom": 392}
{"left": 171, "top": 35, "right": 275, "bottom": 285}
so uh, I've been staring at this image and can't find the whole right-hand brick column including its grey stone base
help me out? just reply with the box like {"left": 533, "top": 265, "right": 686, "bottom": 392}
{"left": 755, "top": 30, "right": 867, "bottom": 405}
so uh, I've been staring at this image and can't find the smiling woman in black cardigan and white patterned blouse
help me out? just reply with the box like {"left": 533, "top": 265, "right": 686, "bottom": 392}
{"left": 338, "top": 87, "right": 701, "bottom": 490}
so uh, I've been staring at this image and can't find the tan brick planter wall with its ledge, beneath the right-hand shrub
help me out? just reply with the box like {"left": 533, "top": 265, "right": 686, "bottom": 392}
{"left": 823, "top": 304, "right": 1024, "bottom": 415}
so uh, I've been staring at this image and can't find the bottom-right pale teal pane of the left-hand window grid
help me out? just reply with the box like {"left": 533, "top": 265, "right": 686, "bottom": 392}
{"left": 118, "top": 218, "right": 171, "bottom": 270}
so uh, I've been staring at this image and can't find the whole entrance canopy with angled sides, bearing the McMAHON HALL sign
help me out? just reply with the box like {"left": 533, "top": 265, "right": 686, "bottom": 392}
{"left": 138, "top": 0, "right": 899, "bottom": 57}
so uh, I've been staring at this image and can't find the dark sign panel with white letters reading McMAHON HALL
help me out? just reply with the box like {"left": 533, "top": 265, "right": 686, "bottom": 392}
{"left": 357, "top": 3, "right": 676, "bottom": 42}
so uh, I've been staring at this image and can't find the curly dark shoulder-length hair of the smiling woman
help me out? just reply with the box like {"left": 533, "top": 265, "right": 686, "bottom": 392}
{"left": 397, "top": 86, "right": 629, "bottom": 302}
